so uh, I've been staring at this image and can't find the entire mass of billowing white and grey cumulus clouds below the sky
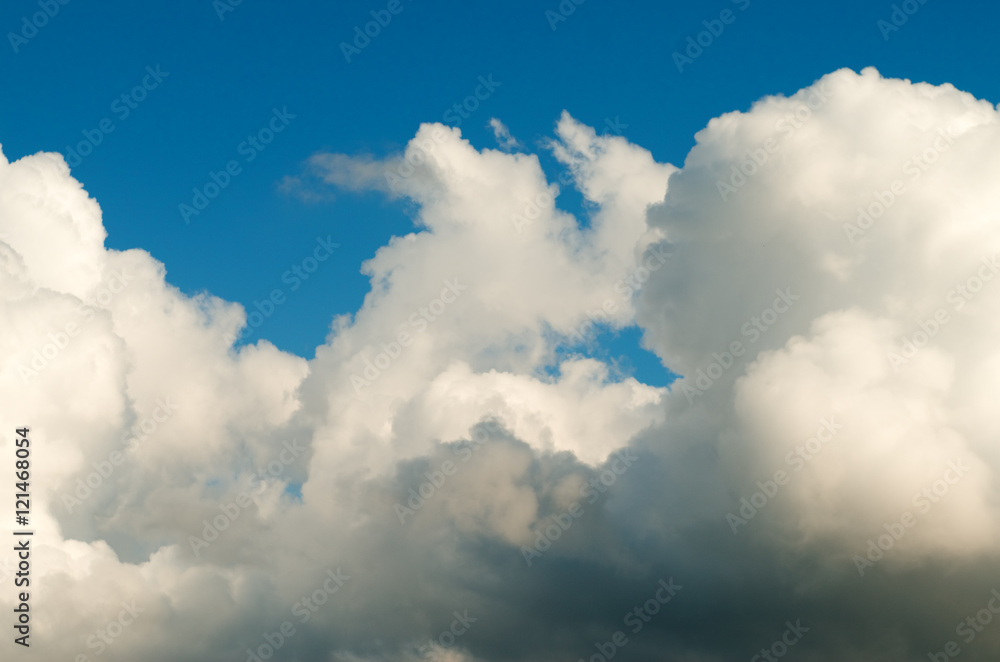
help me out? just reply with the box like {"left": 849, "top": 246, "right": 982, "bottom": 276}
{"left": 0, "top": 69, "right": 1000, "bottom": 662}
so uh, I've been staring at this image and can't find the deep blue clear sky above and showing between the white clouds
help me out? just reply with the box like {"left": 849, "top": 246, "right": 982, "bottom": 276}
{"left": 0, "top": 0, "right": 1000, "bottom": 384}
